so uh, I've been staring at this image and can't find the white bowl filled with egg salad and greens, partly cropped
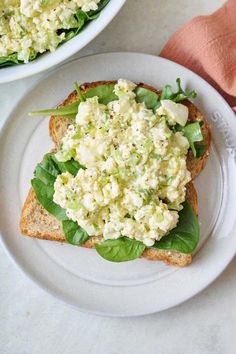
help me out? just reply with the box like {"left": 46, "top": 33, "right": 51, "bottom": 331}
{"left": 0, "top": 0, "right": 125, "bottom": 83}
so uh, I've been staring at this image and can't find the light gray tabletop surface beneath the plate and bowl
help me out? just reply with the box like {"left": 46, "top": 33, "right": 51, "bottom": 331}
{"left": 0, "top": 0, "right": 236, "bottom": 354}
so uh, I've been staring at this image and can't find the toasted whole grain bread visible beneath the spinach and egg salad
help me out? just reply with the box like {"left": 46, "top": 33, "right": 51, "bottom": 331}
{"left": 20, "top": 81, "right": 211, "bottom": 267}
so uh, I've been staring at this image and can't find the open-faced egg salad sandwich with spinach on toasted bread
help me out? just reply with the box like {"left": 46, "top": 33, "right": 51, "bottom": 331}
{"left": 20, "top": 79, "right": 211, "bottom": 266}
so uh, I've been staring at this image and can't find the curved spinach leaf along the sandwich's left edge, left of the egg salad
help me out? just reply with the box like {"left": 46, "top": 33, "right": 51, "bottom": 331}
{"left": 31, "top": 153, "right": 82, "bottom": 220}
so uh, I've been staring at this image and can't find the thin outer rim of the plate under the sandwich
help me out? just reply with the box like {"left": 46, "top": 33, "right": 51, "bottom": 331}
{"left": 0, "top": 52, "right": 236, "bottom": 317}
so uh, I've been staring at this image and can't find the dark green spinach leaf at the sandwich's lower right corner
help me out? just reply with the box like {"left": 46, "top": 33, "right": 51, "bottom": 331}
{"left": 152, "top": 202, "right": 199, "bottom": 253}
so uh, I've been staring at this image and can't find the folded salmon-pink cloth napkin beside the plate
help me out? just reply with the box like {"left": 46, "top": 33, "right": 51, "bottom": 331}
{"left": 160, "top": 0, "right": 236, "bottom": 112}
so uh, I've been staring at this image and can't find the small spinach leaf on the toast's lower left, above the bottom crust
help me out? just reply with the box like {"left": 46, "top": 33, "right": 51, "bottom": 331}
{"left": 62, "top": 220, "right": 89, "bottom": 245}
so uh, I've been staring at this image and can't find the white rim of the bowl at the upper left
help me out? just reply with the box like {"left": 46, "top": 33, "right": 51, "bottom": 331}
{"left": 0, "top": 0, "right": 125, "bottom": 84}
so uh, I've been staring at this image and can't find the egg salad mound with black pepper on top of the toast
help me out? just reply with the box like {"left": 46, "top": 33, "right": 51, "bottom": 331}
{"left": 53, "top": 79, "right": 191, "bottom": 246}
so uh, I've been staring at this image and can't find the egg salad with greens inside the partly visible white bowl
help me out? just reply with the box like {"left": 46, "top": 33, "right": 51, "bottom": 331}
{"left": 0, "top": 0, "right": 104, "bottom": 64}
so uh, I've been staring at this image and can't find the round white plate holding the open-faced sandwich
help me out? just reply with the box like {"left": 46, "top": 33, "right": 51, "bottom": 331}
{"left": 0, "top": 53, "right": 236, "bottom": 316}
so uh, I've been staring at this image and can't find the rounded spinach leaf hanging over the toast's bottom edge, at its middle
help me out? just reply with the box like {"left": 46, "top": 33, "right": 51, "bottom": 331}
{"left": 95, "top": 237, "right": 145, "bottom": 262}
